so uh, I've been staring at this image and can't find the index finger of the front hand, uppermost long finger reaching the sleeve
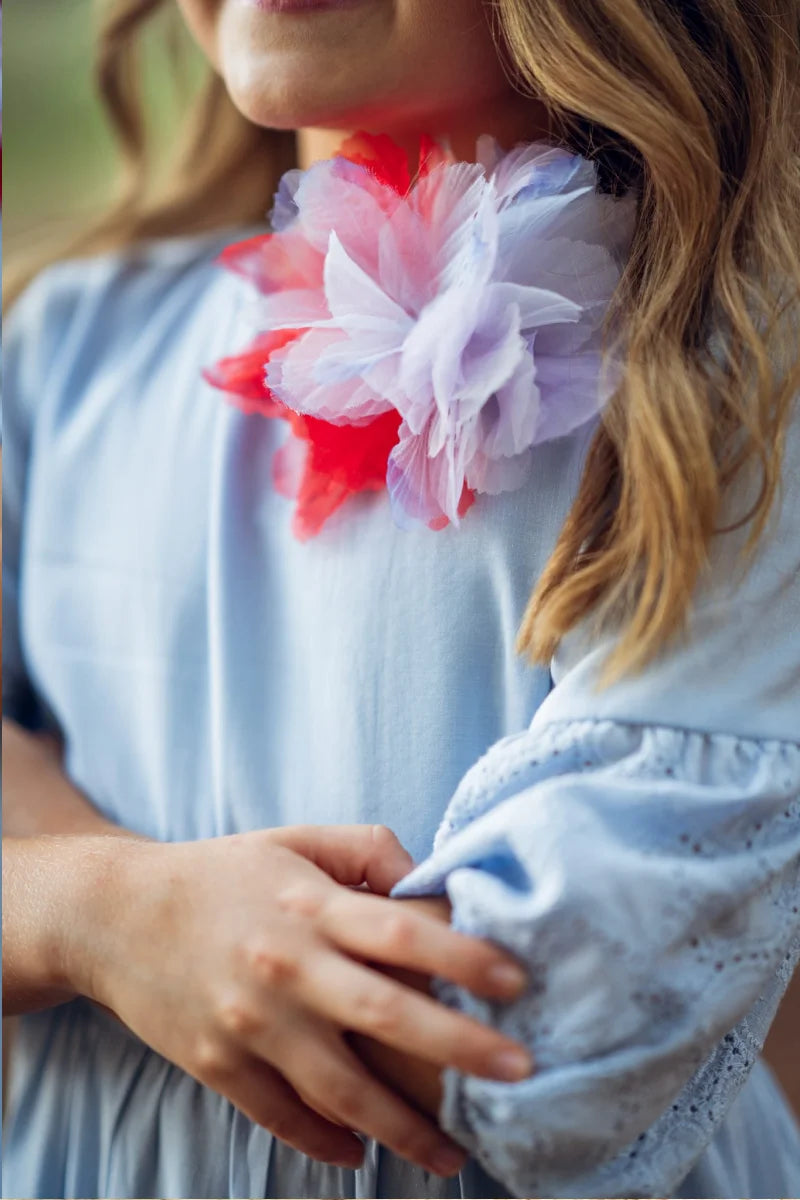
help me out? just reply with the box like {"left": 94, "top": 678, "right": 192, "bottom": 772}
{"left": 320, "top": 889, "right": 528, "bottom": 1000}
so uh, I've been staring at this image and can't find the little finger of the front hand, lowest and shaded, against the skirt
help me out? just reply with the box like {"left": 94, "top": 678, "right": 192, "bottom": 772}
{"left": 216, "top": 1056, "right": 363, "bottom": 1169}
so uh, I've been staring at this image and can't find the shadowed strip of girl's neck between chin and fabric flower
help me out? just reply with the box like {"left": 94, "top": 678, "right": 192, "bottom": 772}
{"left": 297, "top": 94, "right": 551, "bottom": 170}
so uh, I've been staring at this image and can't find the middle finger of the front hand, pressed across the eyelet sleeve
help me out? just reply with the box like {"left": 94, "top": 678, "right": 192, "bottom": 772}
{"left": 296, "top": 950, "right": 533, "bottom": 1082}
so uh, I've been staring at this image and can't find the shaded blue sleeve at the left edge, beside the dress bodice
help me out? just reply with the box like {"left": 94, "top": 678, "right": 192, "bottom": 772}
{"left": 2, "top": 264, "right": 85, "bottom": 730}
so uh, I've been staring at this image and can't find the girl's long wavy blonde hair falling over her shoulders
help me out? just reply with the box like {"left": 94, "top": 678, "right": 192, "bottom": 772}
{"left": 11, "top": 0, "right": 800, "bottom": 679}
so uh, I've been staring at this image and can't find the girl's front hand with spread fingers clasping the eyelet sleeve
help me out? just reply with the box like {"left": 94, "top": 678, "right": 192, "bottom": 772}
{"left": 74, "top": 826, "right": 530, "bottom": 1174}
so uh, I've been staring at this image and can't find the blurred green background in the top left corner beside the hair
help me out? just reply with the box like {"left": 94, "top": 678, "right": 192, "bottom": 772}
{"left": 2, "top": 0, "right": 200, "bottom": 258}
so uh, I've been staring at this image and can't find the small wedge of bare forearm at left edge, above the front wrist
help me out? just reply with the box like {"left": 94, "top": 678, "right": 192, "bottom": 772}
{"left": 2, "top": 720, "right": 133, "bottom": 838}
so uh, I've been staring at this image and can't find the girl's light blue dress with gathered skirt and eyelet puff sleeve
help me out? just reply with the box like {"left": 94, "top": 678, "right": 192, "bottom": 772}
{"left": 4, "top": 230, "right": 800, "bottom": 1198}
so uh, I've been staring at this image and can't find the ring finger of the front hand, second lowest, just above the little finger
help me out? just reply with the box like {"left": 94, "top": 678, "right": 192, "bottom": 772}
{"left": 272, "top": 1026, "right": 467, "bottom": 1175}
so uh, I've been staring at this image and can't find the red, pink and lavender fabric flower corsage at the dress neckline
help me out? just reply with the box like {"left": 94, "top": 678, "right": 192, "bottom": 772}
{"left": 204, "top": 134, "right": 633, "bottom": 539}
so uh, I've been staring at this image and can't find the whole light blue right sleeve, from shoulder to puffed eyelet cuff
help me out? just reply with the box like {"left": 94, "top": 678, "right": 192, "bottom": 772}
{"left": 392, "top": 400, "right": 800, "bottom": 1196}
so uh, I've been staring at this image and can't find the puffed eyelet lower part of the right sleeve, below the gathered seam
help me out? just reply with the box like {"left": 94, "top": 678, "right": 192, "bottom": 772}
{"left": 396, "top": 721, "right": 800, "bottom": 1196}
